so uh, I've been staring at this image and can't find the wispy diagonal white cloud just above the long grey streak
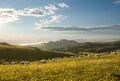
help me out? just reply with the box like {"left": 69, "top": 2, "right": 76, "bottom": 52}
{"left": 35, "top": 15, "right": 65, "bottom": 29}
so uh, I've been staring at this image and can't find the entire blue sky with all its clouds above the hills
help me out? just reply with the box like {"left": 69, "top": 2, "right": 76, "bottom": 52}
{"left": 0, "top": 0, "right": 120, "bottom": 44}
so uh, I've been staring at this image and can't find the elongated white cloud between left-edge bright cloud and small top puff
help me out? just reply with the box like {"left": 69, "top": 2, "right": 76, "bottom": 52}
{"left": 18, "top": 4, "right": 58, "bottom": 17}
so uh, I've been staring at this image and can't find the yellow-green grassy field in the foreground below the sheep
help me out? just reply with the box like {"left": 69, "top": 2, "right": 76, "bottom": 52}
{"left": 0, "top": 54, "right": 120, "bottom": 81}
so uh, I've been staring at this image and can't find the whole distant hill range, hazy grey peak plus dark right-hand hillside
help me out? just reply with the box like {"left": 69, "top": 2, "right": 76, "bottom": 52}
{"left": 36, "top": 40, "right": 120, "bottom": 53}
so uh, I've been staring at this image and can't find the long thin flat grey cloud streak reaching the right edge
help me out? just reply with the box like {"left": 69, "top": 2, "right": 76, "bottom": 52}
{"left": 35, "top": 25, "right": 120, "bottom": 31}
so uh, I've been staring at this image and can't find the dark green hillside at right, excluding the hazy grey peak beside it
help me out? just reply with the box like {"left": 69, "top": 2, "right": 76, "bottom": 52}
{"left": 64, "top": 41, "right": 120, "bottom": 53}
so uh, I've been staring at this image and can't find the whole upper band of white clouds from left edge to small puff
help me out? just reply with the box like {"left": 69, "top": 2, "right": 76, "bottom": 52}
{"left": 0, "top": 3, "right": 68, "bottom": 23}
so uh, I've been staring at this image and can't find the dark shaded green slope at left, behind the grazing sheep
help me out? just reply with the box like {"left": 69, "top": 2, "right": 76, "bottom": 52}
{"left": 0, "top": 45, "right": 69, "bottom": 61}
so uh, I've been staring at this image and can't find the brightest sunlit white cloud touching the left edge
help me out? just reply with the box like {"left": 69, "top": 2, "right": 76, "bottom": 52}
{"left": 0, "top": 8, "right": 18, "bottom": 23}
